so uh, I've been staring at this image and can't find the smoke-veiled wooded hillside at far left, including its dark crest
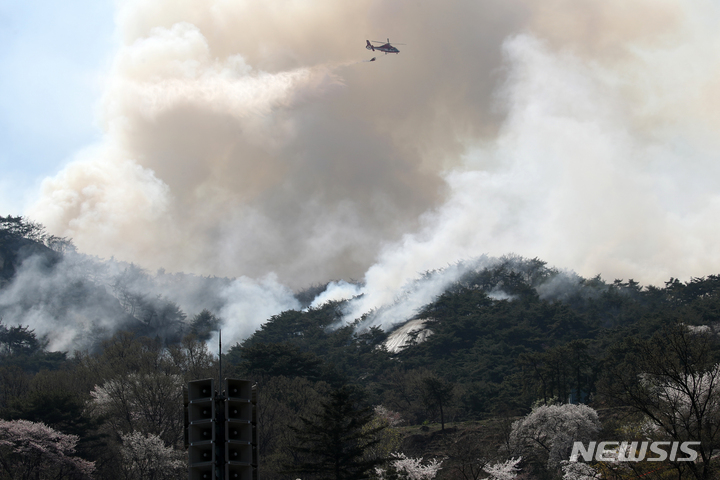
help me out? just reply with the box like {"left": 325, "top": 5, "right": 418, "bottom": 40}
{"left": 0, "top": 216, "right": 242, "bottom": 351}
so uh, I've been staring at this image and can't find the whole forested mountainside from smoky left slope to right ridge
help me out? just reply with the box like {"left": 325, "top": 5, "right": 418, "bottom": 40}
{"left": 0, "top": 217, "right": 720, "bottom": 479}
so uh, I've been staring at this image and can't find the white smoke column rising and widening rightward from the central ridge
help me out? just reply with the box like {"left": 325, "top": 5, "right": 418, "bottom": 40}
{"left": 330, "top": 22, "right": 720, "bottom": 326}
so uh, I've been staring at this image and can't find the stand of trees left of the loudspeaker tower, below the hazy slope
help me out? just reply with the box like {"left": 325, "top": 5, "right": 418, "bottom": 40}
{"left": 0, "top": 325, "right": 217, "bottom": 480}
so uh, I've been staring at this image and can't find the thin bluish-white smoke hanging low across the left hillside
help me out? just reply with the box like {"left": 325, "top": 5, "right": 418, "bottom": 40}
{"left": 0, "top": 251, "right": 301, "bottom": 351}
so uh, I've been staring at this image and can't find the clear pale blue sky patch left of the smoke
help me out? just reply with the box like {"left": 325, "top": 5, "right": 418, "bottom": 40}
{"left": 0, "top": 0, "right": 114, "bottom": 215}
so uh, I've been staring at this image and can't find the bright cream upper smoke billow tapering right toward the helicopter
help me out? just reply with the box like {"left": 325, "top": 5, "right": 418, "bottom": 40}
{"left": 105, "top": 22, "right": 341, "bottom": 128}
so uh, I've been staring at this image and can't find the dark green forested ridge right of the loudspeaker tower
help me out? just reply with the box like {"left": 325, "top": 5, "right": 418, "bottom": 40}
{"left": 222, "top": 257, "right": 720, "bottom": 478}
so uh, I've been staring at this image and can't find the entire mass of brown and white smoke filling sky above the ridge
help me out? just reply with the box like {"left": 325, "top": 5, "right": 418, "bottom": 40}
{"left": 16, "top": 0, "right": 720, "bottom": 338}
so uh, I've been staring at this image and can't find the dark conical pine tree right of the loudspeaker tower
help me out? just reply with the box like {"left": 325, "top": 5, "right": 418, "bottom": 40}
{"left": 286, "top": 385, "right": 385, "bottom": 480}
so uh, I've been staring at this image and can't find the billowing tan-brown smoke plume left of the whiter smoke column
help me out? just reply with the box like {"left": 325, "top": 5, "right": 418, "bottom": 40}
{"left": 28, "top": 2, "right": 519, "bottom": 287}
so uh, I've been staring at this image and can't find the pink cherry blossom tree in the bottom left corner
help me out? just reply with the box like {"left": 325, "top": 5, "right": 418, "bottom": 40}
{"left": 0, "top": 420, "right": 95, "bottom": 480}
